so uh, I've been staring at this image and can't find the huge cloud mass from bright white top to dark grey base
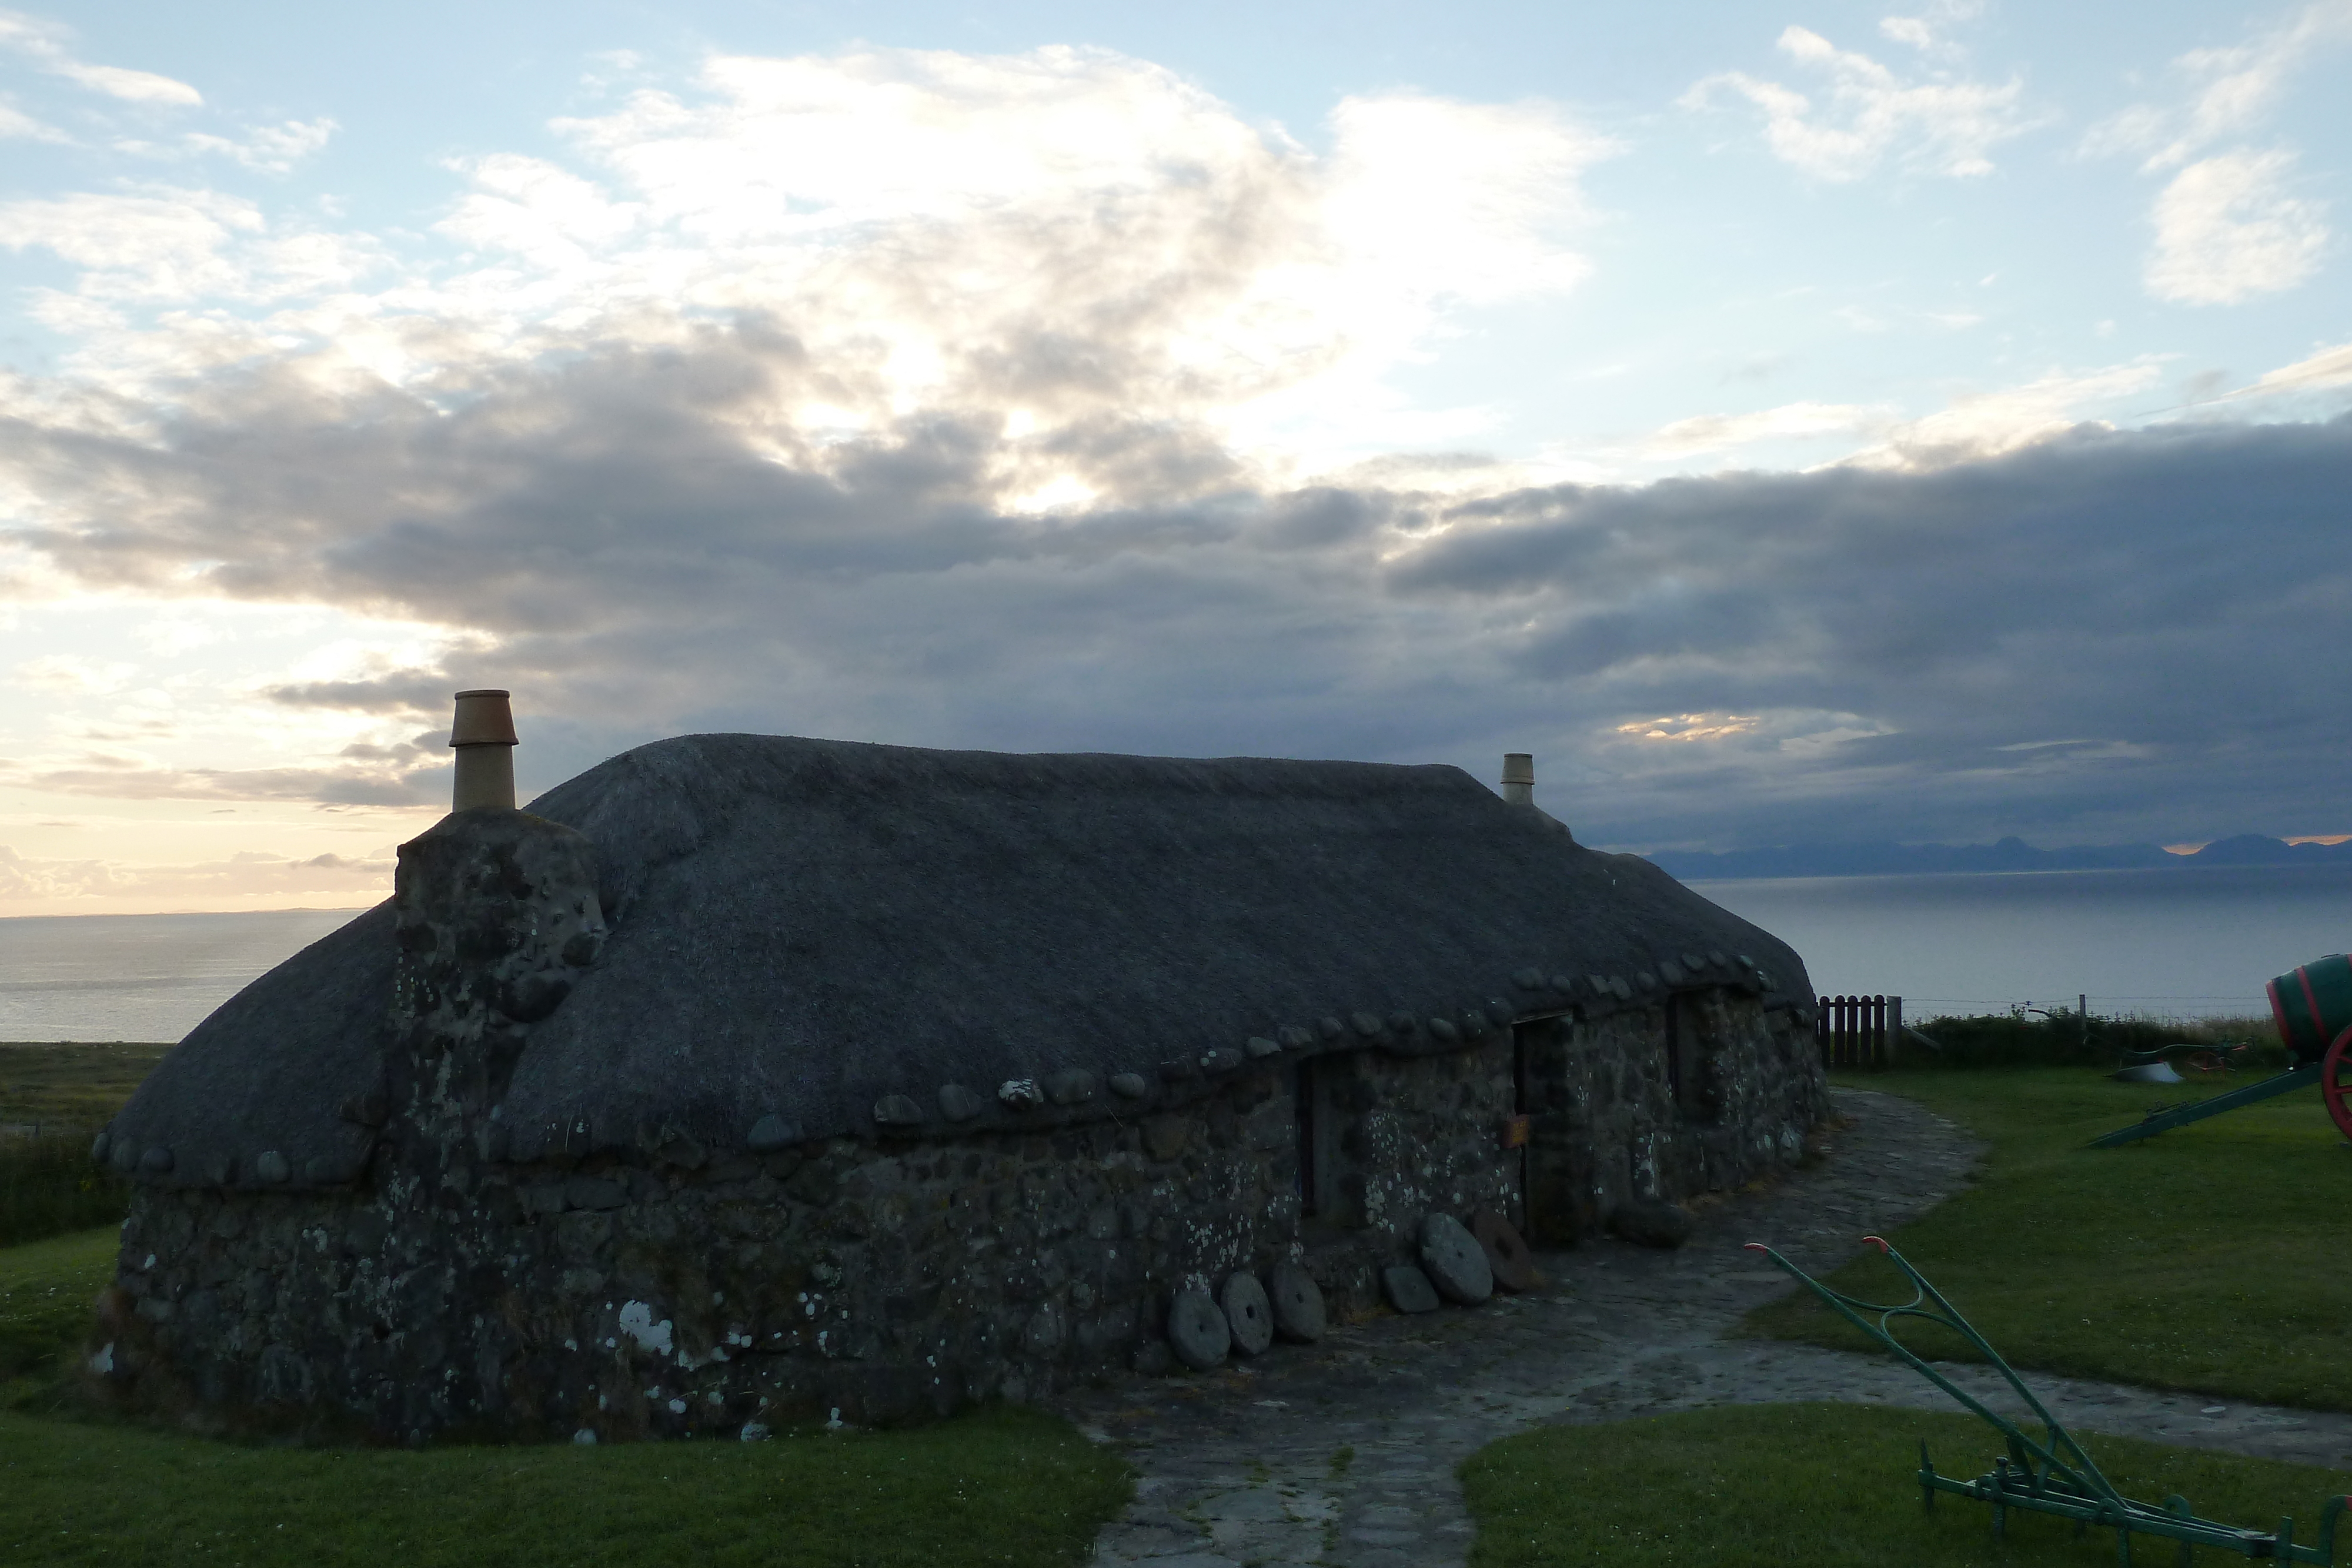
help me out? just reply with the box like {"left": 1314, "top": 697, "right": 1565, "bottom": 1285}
{"left": 0, "top": 52, "right": 2352, "bottom": 846}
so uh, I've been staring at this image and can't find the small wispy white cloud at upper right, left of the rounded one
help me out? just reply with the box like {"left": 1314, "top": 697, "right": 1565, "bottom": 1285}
{"left": 1677, "top": 19, "right": 2034, "bottom": 183}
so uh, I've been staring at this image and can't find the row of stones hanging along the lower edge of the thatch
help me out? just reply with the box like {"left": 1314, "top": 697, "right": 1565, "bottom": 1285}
{"left": 89, "top": 952, "right": 1804, "bottom": 1187}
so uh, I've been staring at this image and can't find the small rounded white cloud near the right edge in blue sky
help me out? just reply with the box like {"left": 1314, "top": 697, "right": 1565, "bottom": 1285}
{"left": 2145, "top": 151, "right": 2328, "bottom": 306}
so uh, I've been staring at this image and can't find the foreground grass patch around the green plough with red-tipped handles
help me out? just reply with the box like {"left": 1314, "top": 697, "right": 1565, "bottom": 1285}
{"left": 1461, "top": 1403, "right": 2347, "bottom": 1568}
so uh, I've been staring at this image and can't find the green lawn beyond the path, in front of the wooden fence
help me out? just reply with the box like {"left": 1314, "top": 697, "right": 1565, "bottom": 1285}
{"left": 1748, "top": 1067, "right": 2352, "bottom": 1410}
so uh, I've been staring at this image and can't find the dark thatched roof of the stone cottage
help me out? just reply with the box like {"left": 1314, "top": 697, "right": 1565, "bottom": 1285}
{"left": 101, "top": 736, "right": 1809, "bottom": 1185}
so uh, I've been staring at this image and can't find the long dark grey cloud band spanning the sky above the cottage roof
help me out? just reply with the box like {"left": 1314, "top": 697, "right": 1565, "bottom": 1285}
{"left": 0, "top": 317, "right": 2352, "bottom": 848}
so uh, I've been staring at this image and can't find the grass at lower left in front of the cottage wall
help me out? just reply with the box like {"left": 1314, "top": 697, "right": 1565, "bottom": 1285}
{"left": 0, "top": 1229, "right": 1131, "bottom": 1568}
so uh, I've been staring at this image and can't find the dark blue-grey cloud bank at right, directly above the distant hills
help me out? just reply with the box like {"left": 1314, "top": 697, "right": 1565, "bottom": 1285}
{"left": 1388, "top": 421, "right": 2352, "bottom": 841}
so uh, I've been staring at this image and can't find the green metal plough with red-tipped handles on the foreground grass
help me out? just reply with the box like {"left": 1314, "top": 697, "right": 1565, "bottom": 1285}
{"left": 1748, "top": 1236, "right": 2352, "bottom": 1563}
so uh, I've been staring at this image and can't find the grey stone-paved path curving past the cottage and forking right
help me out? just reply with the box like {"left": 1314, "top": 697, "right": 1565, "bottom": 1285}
{"left": 1063, "top": 1091, "right": 2352, "bottom": 1568}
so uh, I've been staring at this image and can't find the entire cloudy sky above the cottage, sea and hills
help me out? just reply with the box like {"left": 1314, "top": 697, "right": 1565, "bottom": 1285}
{"left": 0, "top": 0, "right": 2352, "bottom": 914}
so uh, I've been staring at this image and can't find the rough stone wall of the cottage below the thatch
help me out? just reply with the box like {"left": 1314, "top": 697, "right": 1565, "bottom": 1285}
{"left": 94, "top": 989, "right": 1823, "bottom": 1441}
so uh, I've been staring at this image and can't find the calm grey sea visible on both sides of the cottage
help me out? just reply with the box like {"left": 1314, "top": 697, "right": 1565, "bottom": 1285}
{"left": 0, "top": 865, "right": 2352, "bottom": 1041}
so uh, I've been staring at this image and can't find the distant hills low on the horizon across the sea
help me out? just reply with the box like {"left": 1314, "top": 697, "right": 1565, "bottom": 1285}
{"left": 1649, "top": 832, "right": 2352, "bottom": 881}
